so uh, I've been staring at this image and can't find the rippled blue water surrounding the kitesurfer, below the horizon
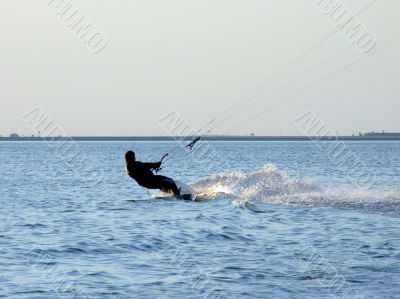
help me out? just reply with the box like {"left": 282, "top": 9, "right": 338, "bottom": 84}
{"left": 0, "top": 141, "right": 400, "bottom": 298}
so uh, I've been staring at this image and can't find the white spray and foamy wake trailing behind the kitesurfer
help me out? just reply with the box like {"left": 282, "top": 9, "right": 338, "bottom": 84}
{"left": 190, "top": 165, "right": 400, "bottom": 211}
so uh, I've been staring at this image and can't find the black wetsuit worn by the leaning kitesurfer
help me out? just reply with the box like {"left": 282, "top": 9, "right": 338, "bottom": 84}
{"left": 127, "top": 161, "right": 179, "bottom": 195}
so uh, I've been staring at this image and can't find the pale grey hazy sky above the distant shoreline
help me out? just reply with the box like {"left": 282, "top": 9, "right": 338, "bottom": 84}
{"left": 0, "top": 0, "right": 400, "bottom": 136}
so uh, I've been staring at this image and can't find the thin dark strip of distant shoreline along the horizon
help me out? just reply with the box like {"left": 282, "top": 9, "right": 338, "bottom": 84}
{"left": 0, "top": 134, "right": 400, "bottom": 141}
